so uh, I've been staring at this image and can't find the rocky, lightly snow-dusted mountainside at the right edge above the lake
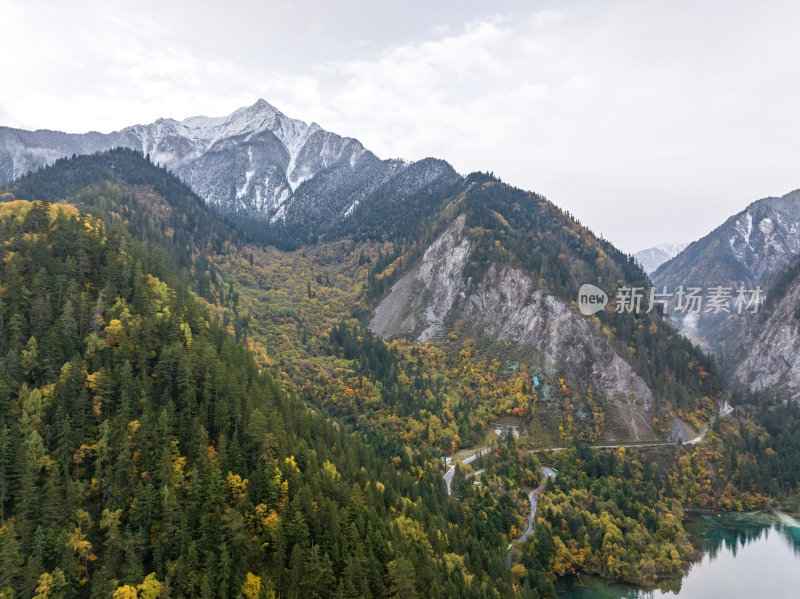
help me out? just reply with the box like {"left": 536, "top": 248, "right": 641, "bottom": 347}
{"left": 650, "top": 190, "right": 800, "bottom": 396}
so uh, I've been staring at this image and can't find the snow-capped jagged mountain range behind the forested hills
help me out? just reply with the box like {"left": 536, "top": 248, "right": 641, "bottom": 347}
{"left": 0, "top": 100, "right": 457, "bottom": 238}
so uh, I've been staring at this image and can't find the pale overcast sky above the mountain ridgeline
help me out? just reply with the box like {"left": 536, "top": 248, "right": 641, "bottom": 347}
{"left": 0, "top": 0, "right": 800, "bottom": 251}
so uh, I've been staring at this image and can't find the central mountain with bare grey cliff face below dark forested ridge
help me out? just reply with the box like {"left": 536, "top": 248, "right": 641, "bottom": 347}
{"left": 367, "top": 174, "right": 722, "bottom": 441}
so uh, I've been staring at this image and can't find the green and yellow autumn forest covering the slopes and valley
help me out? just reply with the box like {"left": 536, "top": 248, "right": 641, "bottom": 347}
{"left": 0, "top": 149, "right": 800, "bottom": 599}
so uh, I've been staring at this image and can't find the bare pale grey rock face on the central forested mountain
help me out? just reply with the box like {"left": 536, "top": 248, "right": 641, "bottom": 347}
{"left": 369, "top": 215, "right": 654, "bottom": 439}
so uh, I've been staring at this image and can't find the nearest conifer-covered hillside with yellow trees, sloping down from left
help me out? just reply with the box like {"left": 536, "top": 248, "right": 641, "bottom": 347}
{"left": 0, "top": 157, "right": 552, "bottom": 597}
